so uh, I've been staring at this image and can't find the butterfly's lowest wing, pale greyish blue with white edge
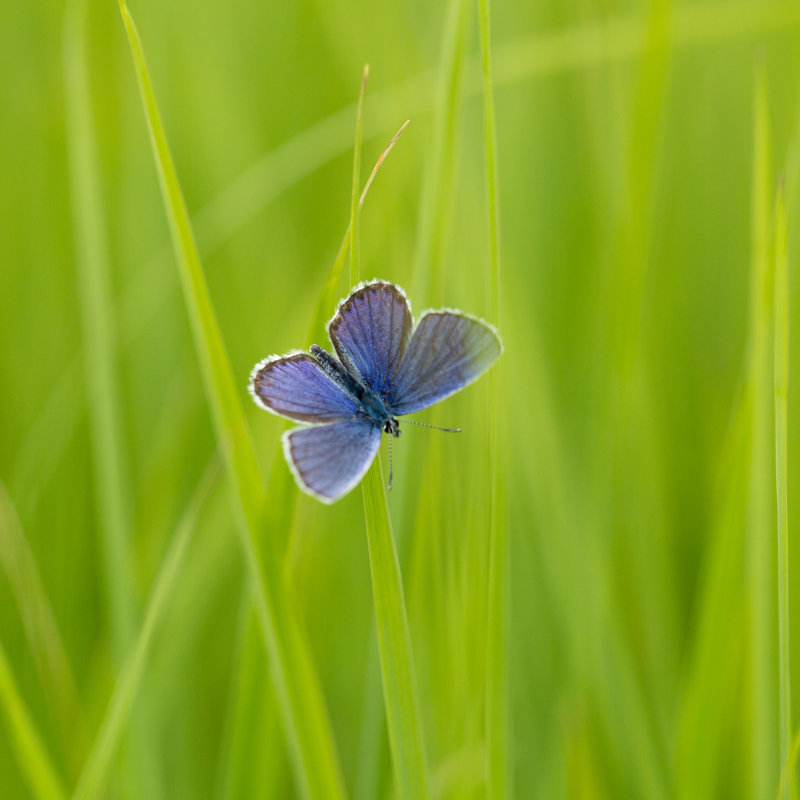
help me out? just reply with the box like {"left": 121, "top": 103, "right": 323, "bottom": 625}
{"left": 283, "top": 418, "right": 381, "bottom": 503}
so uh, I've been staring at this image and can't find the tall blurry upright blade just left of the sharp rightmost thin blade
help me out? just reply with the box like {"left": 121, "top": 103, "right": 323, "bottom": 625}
{"left": 748, "top": 59, "right": 777, "bottom": 797}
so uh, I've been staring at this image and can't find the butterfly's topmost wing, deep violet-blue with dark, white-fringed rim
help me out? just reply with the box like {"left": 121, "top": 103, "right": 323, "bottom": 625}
{"left": 328, "top": 281, "right": 414, "bottom": 396}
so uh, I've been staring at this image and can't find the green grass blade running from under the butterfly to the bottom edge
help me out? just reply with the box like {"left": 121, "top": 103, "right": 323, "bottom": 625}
{"left": 362, "top": 456, "right": 428, "bottom": 800}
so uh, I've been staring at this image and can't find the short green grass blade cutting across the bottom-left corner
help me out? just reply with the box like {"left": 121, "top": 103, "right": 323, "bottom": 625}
{"left": 0, "top": 643, "right": 65, "bottom": 800}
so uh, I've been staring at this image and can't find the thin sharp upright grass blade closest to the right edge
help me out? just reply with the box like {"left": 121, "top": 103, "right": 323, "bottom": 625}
{"left": 774, "top": 187, "right": 794, "bottom": 800}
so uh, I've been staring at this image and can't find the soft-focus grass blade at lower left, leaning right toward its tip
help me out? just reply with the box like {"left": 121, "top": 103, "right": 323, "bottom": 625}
{"left": 72, "top": 457, "right": 219, "bottom": 800}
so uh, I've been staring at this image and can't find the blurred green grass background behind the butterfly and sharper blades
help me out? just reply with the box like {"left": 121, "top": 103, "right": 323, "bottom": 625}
{"left": 0, "top": 0, "right": 800, "bottom": 798}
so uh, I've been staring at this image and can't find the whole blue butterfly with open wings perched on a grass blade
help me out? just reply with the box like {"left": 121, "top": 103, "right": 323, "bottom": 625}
{"left": 250, "top": 280, "right": 503, "bottom": 503}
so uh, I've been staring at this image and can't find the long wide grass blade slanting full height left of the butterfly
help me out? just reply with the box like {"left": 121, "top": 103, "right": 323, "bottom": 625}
{"left": 120, "top": 0, "right": 344, "bottom": 798}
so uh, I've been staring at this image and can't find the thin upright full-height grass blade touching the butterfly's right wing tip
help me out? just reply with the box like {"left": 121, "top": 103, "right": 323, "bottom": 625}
{"left": 478, "top": 0, "right": 510, "bottom": 800}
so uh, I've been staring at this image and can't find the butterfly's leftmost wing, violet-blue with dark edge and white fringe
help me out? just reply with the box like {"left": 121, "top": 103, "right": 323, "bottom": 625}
{"left": 250, "top": 352, "right": 358, "bottom": 423}
